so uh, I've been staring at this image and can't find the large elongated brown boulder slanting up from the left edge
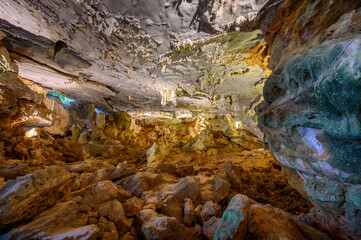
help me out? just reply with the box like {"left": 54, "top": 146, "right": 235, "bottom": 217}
{"left": 0, "top": 166, "right": 74, "bottom": 227}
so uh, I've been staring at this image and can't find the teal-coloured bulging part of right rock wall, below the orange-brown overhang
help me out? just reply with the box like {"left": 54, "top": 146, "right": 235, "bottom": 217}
{"left": 258, "top": 34, "right": 361, "bottom": 238}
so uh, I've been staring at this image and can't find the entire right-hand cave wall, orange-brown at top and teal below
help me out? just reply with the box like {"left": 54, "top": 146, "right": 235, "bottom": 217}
{"left": 259, "top": 1, "right": 361, "bottom": 239}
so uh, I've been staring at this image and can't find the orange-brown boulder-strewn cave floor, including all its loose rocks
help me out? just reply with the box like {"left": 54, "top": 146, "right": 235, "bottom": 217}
{"left": 0, "top": 104, "right": 329, "bottom": 240}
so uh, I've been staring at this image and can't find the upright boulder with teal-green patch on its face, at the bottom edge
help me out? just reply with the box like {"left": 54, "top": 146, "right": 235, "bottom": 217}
{"left": 214, "top": 194, "right": 256, "bottom": 240}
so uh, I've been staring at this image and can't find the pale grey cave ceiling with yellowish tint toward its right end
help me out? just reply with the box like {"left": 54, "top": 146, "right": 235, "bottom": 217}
{"left": 0, "top": 0, "right": 282, "bottom": 118}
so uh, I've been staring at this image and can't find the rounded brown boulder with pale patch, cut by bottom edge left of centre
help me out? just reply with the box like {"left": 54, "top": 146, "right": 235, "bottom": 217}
{"left": 137, "top": 209, "right": 184, "bottom": 240}
